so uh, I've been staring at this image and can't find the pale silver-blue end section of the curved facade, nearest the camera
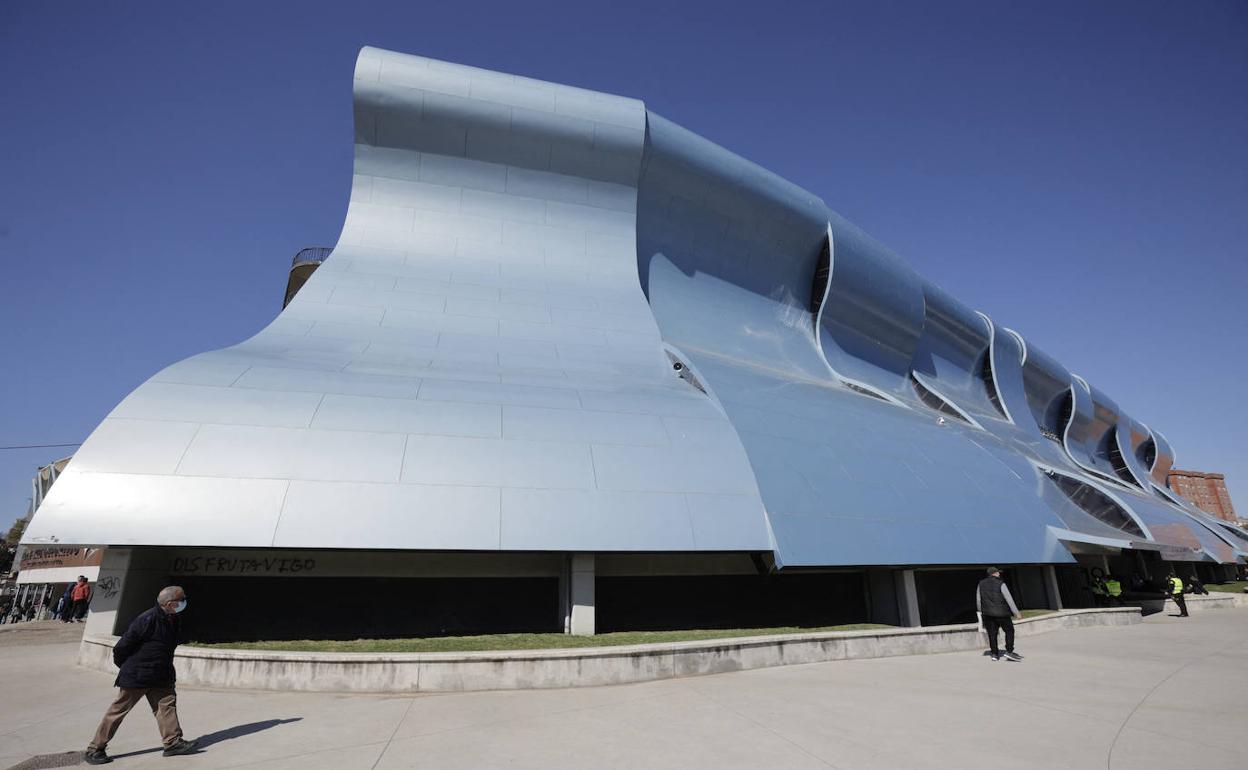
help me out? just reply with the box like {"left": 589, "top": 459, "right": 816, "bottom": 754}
{"left": 31, "top": 49, "right": 771, "bottom": 552}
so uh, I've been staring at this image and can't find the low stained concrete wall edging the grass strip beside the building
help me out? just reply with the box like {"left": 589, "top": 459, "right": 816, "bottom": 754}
{"left": 79, "top": 607, "right": 1142, "bottom": 693}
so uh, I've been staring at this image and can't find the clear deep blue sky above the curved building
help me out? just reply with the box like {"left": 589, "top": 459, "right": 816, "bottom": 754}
{"left": 0, "top": 0, "right": 1248, "bottom": 522}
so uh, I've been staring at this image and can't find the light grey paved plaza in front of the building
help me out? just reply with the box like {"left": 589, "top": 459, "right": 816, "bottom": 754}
{"left": 0, "top": 609, "right": 1248, "bottom": 770}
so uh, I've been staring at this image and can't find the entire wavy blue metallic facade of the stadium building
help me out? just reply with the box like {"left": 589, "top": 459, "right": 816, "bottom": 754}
{"left": 27, "top": 49, "right": 1246, "bottom": 567}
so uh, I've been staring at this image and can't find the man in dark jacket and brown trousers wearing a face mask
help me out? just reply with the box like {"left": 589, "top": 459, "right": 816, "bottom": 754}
{"left": 84, "top": 585, "right": 196, "bottom": 765}
